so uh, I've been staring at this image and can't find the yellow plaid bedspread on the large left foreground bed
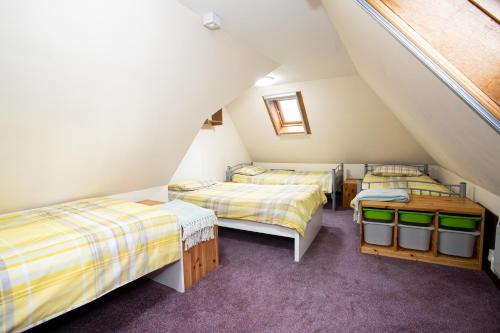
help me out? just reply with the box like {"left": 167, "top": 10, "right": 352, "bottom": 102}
{"left": 0, "top": 198, "right": 180, "bottom": 332}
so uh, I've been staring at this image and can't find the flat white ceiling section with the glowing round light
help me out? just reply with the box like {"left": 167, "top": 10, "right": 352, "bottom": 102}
{"left": 178, "top": 0, "right": 356, "bottom": 83}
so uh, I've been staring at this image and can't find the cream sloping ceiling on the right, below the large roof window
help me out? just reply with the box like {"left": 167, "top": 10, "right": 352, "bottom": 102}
{"left": 322, "top": 0, "right": 500, "bottom": 195}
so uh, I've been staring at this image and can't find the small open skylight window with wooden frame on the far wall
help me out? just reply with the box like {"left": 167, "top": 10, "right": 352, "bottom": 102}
{"left": 264, "top": 91, "right": 311, "bottom": 135}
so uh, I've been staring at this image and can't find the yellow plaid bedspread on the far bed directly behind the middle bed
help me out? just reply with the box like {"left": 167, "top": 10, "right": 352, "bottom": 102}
{"left": 233, "top": 170, "right": 332, "bottom": 193}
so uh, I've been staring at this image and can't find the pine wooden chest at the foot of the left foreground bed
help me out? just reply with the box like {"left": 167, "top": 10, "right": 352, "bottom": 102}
{"left": 137, "top": 200, "right": 219, "bottom": 289}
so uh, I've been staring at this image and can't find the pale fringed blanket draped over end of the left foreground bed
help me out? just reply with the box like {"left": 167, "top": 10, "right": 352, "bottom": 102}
{"left": 156, "top": 200, "right": 217, "bottom": 251}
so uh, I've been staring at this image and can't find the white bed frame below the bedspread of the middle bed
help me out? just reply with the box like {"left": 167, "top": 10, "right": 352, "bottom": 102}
{"left": 218, "top": 207, "right": 323, "bottom": 262}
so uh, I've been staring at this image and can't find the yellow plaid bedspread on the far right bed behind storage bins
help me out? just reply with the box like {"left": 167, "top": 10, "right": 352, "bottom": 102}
{"left": 362, "top": 173, "right": 456, "bottom": 196}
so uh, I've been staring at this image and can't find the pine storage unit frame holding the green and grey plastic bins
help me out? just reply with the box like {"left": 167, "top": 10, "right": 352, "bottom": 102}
{"left": 359, "top": 195, "right": 485, "bottom": 270}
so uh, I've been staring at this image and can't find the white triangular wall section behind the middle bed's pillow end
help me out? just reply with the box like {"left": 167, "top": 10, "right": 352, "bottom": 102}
{"left": 170, "top": 110, "right": 250, "bottom": 183}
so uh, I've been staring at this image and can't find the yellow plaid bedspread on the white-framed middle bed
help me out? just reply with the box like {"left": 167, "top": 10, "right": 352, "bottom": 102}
{"left": 168, "top": 183, "right": 327, "bottom": 235}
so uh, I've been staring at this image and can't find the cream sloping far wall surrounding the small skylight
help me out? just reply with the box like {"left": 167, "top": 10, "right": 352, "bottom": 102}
{"left": 227, "top": 76, "right": 432, "bottom": 163}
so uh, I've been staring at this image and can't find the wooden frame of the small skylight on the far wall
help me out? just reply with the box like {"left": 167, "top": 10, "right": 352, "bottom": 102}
{"left": 262, "top": 91, "right": 311, "bottom": 135}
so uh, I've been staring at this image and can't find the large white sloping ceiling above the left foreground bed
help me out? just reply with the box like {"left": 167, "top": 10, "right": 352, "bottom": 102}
{"left": 0, "top": 0, "right": 276, "bottom": 212}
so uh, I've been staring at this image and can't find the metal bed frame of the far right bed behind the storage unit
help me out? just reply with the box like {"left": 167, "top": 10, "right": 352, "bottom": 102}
{"left": 357, "top": 163, "right": 467, "bottom": 198}
